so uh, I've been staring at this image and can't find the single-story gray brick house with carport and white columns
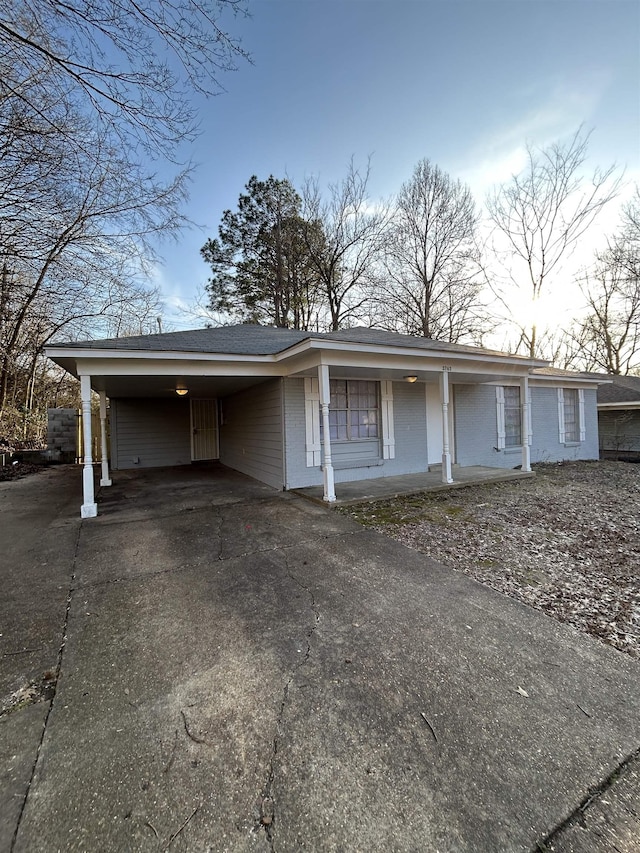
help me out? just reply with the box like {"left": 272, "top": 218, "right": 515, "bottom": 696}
{"left": 46, "top": 325, "right": 598, "bottom": 517}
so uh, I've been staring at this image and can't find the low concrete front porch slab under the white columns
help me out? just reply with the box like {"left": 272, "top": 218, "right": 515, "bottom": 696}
{"left": 292, "top": 465, "right": 535, "bottom": 506}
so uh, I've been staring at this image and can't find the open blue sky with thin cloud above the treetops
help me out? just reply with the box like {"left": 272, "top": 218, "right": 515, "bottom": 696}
{"left": 157, "top": 0, "right": 640, "bottom": 328}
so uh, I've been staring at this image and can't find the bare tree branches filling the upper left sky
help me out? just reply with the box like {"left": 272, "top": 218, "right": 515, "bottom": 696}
{"left": 0, "top": 0, "right": 245, "bottom": 446}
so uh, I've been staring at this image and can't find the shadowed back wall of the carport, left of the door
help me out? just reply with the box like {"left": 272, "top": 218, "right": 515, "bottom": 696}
{"left": 110, "top": 399, "right": 191, "bottom": 469}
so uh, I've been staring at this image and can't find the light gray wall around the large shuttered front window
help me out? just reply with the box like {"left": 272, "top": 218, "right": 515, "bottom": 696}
{"left": 284, "top": 378, "right": 427, "bottom": 489}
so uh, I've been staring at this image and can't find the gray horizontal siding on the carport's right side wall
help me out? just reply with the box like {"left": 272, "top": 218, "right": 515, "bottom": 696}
{"left": 220, "top": 379, "right": 284, "bottom": 489}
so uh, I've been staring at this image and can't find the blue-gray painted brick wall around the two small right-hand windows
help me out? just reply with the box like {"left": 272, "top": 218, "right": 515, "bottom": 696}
{"left": 455, "top": 385, "right": 598, "bottom": 468}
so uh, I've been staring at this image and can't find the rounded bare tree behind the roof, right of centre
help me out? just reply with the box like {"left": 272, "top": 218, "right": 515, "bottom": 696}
{"left": 381, "top": 159, "right": 488, "bottom": 342}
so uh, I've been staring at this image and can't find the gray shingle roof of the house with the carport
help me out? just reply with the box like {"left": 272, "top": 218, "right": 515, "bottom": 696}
{"left": 50, "top": 324, "right": 536, "bottom": 359}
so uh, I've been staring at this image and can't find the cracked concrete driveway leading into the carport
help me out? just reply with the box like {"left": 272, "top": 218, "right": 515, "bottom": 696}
{"left": 0, "top": 467, "right": 640, "bottom": 853}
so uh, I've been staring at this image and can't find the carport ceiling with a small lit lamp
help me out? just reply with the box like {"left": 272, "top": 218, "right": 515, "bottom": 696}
{"left": 91, "top": 376, "right": 268, "bottom": 398}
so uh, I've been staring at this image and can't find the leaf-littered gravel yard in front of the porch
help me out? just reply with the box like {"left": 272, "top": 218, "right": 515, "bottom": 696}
{"left": 341, "top": 462, "right": 640, "bottom": 658}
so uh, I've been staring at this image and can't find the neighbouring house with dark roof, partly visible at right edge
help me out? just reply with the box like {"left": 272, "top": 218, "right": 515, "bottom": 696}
{"left": 598, "top": 376, "right": 640, "bottom": 460}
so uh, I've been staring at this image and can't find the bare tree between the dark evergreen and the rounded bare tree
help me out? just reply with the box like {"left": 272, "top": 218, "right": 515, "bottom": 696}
{"left": 302, "top": 160, "right": 389, "bottom": 331}
